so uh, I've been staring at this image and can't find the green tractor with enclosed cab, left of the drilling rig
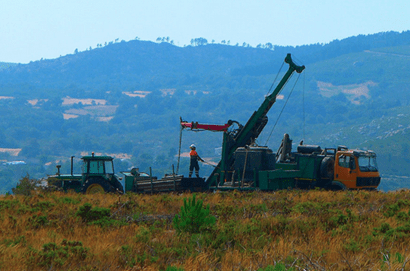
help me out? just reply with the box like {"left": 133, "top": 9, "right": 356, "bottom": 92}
{"left": 47, "top": 153, "right": 124, "bottom": 194}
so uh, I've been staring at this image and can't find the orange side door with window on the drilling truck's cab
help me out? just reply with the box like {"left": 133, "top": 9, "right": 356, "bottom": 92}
{"left": 335, "top": 154, "right": 357, "bottom": 188}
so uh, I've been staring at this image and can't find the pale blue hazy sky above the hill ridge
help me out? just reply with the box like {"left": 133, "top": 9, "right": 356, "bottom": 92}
{"left": 0, "top": 0, "right": 410, "bottom": 63}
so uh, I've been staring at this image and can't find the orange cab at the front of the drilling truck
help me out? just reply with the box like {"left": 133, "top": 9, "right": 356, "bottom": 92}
{"left": 334, "top": 148, "right": 380, "bottom": 189}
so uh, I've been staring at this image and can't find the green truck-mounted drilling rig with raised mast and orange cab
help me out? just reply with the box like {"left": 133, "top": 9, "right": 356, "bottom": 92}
{"left": 181, "top": 54, "right": 380, "bottom": 191}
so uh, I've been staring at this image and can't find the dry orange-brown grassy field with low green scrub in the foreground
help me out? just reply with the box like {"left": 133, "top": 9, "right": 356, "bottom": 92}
{"left": 0, "top": 190, "right": 410, "bottom": 270}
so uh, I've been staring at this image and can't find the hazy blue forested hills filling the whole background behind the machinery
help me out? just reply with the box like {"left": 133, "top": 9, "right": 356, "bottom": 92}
{"left": 0, "top": 31, "right": 410, "bottom": 192}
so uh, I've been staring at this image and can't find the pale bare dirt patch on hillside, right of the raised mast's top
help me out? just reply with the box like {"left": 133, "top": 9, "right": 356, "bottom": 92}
{"left": 317, "top": 81, "right": 377, "bottom": 104}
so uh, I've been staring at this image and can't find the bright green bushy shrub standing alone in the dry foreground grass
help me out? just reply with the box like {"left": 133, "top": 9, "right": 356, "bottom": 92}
{"left": 173, "top": 194, "right": 216, "bottom": 233}
